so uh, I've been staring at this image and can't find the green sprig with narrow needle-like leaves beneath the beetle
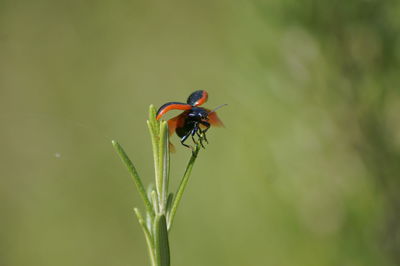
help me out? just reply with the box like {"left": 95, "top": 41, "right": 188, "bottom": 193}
{"left": 112, "top": 105, "right": 200, "bottom": 266}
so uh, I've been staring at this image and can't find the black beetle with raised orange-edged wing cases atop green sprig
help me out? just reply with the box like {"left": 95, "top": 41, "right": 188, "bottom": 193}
{"left": 156, "top": 90, "right": 226, "bottom": 150}
